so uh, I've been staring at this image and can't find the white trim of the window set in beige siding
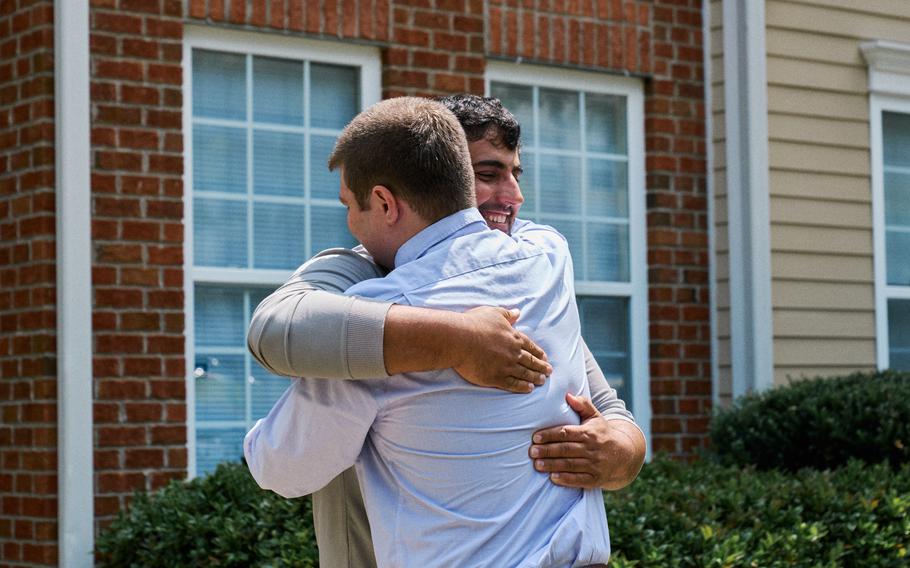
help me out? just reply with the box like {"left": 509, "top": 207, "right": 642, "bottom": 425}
{"left": 860, "top": 40, "right": 910, "bottom": 369}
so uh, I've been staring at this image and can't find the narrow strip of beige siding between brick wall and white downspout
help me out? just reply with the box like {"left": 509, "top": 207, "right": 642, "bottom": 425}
{"left": 709, "top": 0, "right": 733, "bottom": 404}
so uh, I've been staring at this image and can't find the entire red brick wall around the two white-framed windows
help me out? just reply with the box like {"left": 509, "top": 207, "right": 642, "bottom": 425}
{"left": 0, "top": 0, "right": 711, "bottom": 565}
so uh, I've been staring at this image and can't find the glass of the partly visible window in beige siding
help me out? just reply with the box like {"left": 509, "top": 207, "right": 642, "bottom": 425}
{"left": 881, "top": 110, "right": 910, "bottom": 371}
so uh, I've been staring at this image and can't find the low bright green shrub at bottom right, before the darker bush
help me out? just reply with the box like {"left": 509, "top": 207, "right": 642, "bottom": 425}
{"left": 605, "top": 458, "right": 910, "bottom": 568}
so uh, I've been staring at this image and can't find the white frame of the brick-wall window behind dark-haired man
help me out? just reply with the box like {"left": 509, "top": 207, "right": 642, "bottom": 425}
{"left": 485, "top": 61, "right": 651, "bottom": 446}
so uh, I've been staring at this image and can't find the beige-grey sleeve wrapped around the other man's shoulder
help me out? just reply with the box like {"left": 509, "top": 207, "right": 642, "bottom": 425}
{"left": 247, "top": 249, "right": 392, "bottom": 379}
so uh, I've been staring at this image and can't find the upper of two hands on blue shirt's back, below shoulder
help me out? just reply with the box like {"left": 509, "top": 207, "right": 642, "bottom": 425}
{"left": 453, "top": 306, "right": 553, "bottom": 393}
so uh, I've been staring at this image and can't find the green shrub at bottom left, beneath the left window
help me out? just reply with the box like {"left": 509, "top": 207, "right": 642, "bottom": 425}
{"left": 96, "top": 464, "right": 318, "bottom": 568}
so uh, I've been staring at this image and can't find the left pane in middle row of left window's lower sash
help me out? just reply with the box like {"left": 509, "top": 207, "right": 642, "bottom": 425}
{"left": 196, "top": 356, "right": 246, "bottom": 423}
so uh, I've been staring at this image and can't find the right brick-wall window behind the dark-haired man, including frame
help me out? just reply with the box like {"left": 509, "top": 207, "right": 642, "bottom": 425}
{"left": 487, "top": 63, "right": 650, "bottom": 434}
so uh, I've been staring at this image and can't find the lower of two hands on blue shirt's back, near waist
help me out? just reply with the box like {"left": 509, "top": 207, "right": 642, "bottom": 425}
{"left": 528, "top": 393, "right": 645, "bottom": 491}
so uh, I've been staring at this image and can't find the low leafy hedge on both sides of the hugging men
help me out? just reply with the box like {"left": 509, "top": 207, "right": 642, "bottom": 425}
{"left": 97, "top": 457, "right": 910, "bottom": 568}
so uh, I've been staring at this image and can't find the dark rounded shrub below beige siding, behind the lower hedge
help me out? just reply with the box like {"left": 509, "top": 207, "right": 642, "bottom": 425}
{"left": 711, "top": 371, "right": 910, "bottom": 471}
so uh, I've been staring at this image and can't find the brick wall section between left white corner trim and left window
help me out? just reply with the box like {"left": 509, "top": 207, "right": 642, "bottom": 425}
{"left": 91, "top": 0, "right": 187, "bottom": 525}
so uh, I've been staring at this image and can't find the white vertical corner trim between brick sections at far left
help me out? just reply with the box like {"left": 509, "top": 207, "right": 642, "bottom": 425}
{"left": 54, "top": 0, "right": 95, "bottom": 567}
